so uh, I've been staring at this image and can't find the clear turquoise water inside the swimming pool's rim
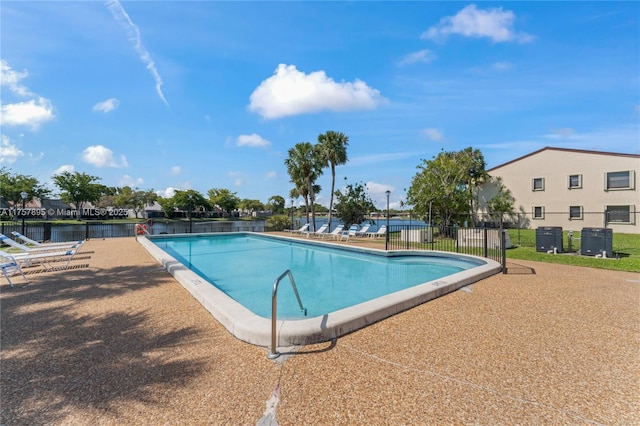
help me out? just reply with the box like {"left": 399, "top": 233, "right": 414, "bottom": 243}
{"left": 153, "top": 234, "right": 482, "bottom": 319}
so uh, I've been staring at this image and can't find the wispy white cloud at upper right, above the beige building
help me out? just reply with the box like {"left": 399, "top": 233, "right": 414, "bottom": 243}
{"left": 420, "top": 4, "right": 533, "bottom": 43}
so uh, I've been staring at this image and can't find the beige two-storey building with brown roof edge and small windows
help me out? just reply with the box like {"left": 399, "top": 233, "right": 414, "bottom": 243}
{"left": 478, "top": 147, "right": 640, "bottom": 234}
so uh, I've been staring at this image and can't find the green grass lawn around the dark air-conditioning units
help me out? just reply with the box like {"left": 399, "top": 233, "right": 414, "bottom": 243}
{"left": 507, "top": 229, "right": 640, "bottom": 272}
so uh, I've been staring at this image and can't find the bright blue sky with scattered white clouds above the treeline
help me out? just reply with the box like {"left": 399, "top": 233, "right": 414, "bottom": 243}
{"left": 0, "top": 0, "right": 640, "bottom": 208}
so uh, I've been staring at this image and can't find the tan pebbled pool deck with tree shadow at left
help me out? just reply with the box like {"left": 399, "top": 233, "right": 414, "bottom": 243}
{"left": 0, "top": 238, "right": 640, "bottom": 425}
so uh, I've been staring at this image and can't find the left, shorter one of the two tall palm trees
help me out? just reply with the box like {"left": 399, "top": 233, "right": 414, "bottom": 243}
{"left": 284, "top": 142, "right": 322, "bottom": 230}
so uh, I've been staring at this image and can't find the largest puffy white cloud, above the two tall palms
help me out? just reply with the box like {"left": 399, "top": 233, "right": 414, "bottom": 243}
{"left": 248, "top": 64, "right": 387, "bottom": 119}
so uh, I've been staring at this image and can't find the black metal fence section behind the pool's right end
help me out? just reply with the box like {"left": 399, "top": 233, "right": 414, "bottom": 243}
{"left": 385, "top": 225, "right": 510, "bottom": 273}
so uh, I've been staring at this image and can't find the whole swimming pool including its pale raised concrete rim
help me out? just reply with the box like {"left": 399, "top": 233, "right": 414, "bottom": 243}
{"left": 139, "top": 233, "right": 500, "bottom": 346}
